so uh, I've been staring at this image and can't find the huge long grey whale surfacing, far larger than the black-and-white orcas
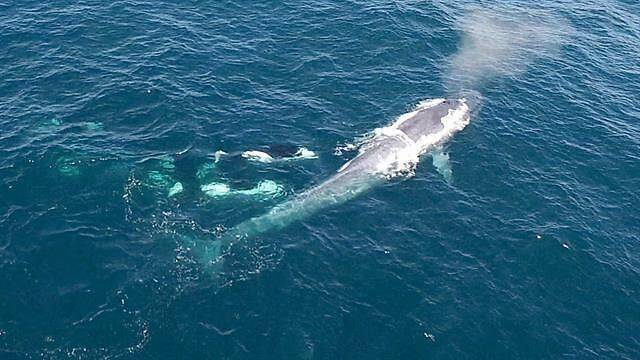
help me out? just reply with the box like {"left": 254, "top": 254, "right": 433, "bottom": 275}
{"left": 190, "top": 99, "right": 470, "bottom": 268}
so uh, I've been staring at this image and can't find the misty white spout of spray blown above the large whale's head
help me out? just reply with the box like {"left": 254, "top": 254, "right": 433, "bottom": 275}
{"left": 444, "top": 4, "right": 573, "bottom": 94}
